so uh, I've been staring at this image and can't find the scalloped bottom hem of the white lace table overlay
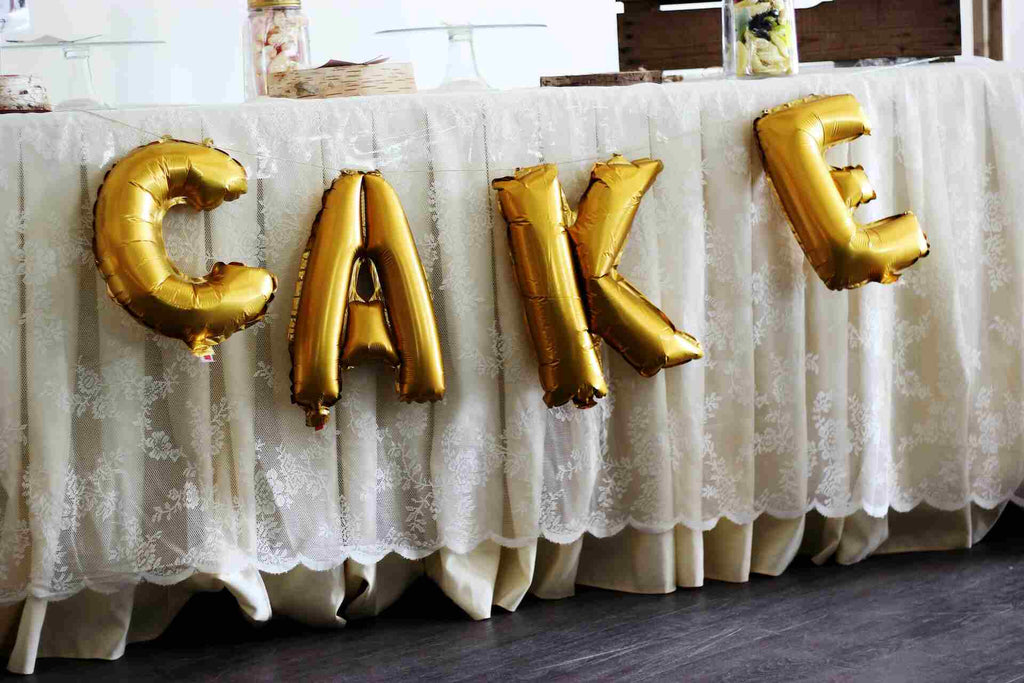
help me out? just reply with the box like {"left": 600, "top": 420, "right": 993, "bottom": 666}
{"left": 0, "top": 495, "right": 1024, "bottom": 606}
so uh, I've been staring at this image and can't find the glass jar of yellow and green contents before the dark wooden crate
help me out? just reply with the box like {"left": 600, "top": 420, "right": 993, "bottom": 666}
{"left": 722, "top": 0, "right": 800, "bottom": 78}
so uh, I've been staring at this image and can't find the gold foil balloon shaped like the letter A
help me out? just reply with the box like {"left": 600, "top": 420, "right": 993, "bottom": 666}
{"left": 289, "top": 171, "right": 444, "bottom": 429}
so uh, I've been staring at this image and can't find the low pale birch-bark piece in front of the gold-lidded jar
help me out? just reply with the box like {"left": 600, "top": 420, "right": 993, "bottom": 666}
{"left": 267, "top": 61, "right": 416, "bottom": 99}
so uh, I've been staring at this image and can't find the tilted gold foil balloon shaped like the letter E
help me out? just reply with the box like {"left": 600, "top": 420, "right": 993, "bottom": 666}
{"left": 754, "top": 95, "right": 929, "bottom": 290}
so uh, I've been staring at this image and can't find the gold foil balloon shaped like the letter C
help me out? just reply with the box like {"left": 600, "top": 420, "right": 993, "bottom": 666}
{"left": 93, "top": 139, "right": 278, "bottom": 357}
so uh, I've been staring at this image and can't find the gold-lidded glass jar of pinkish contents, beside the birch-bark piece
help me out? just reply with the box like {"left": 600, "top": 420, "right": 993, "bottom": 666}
{"left": 243, "top": 0, "right": 309, "bottom": 99}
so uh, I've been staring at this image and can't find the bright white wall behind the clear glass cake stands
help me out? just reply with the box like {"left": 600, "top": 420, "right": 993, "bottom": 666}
{"left": 3, "top": 0, "right": 618, "bottom": 104}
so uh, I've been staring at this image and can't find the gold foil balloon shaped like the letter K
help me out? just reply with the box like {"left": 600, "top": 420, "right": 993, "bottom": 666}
{"left": 494, "top": 155, "right": 703, "bottom": 408}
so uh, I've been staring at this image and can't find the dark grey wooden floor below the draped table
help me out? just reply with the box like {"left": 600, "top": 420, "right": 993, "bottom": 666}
{"left": 14, "top": 510, "right": 1024, "bottom": 683}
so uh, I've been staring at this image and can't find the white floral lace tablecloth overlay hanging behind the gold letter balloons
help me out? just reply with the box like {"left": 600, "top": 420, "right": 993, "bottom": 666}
{"left": 0, "top": 66, "right": 1024, "bottom": 602}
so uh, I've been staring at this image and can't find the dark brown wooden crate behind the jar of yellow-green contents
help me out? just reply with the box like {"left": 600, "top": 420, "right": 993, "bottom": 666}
{"left": 618, "top": 0, "right": 961, "bottom": 70}
